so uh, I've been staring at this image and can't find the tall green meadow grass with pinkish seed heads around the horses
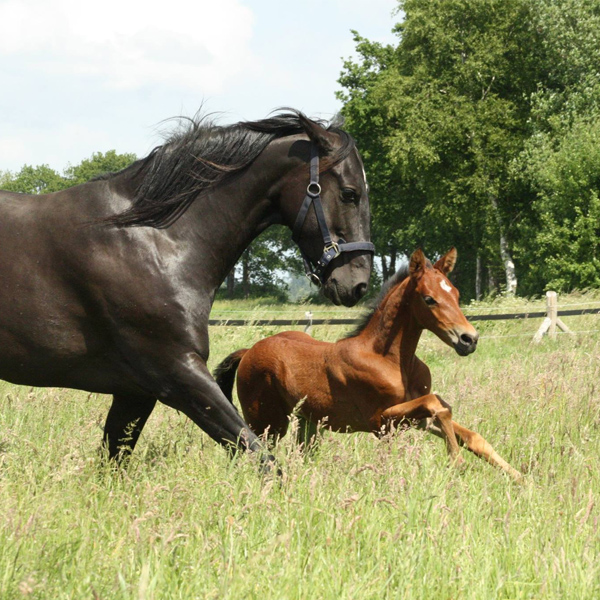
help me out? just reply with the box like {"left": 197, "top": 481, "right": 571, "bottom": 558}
{"left": 0, "top": 297, "right": 600, "bottom": 600}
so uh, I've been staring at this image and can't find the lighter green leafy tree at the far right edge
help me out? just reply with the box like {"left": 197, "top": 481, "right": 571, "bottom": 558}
{"left": 514, "top": 0, "right": 600, "bottom": 294}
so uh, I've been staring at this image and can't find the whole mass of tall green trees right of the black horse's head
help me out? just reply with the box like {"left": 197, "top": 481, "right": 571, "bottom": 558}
{"left": 339, "top": 0, "right": 600, "bottom": 297}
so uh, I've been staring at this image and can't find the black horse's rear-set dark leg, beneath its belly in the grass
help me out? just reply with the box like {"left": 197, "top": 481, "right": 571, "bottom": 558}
{"left": 104, "top": 394, "right": 156, "bottom": 461}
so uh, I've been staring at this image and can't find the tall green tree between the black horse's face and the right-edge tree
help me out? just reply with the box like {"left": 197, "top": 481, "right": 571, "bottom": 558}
{"left": 340, "top": 0, "right": 542, "bottom": 295}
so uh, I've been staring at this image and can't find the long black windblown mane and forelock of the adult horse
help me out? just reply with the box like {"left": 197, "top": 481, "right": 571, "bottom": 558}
{"left": 105, "top": 109, "right": 354, "bottom": 227}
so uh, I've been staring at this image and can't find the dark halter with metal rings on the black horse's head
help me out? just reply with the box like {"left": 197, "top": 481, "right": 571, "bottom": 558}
{"left": 292, "top": 144, "right": 375, "bottom": 287}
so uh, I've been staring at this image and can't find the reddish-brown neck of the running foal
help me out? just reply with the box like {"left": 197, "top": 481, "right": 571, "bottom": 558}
{"left": 364, "top": 280, "right": 423, "bottom": 369}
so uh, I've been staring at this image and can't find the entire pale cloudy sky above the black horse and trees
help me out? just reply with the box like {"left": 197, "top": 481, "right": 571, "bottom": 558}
{"left": 0, "top": 0, "right": 398, "bottom": 171}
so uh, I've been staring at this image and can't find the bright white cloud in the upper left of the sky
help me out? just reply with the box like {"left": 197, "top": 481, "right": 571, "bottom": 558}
{"left": 0, "top": 0, "right": 254, "bottom": 94}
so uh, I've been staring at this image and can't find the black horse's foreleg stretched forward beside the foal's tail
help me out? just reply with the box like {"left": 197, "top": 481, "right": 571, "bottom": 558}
{"left": 158, "top": 352, "right": 275, "bottom": 473}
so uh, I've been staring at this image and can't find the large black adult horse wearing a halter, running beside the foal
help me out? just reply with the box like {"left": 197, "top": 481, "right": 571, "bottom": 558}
{"left": 0, "top": 112, "right": 372, "bottom": 466}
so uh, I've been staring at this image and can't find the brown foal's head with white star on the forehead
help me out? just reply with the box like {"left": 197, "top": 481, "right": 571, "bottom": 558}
{"left": 409, "top": 248, "right": 479, "bottom": 356}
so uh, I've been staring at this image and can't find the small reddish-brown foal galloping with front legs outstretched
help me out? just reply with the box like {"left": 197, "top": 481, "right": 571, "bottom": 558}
{"left": 215, "top": 248, "right": 522, "bottom": 480}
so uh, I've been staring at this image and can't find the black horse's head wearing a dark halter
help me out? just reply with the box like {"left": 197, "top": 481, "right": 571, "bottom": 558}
{"left": 280, "top": 115, "right": 374, "bottom": 306}
